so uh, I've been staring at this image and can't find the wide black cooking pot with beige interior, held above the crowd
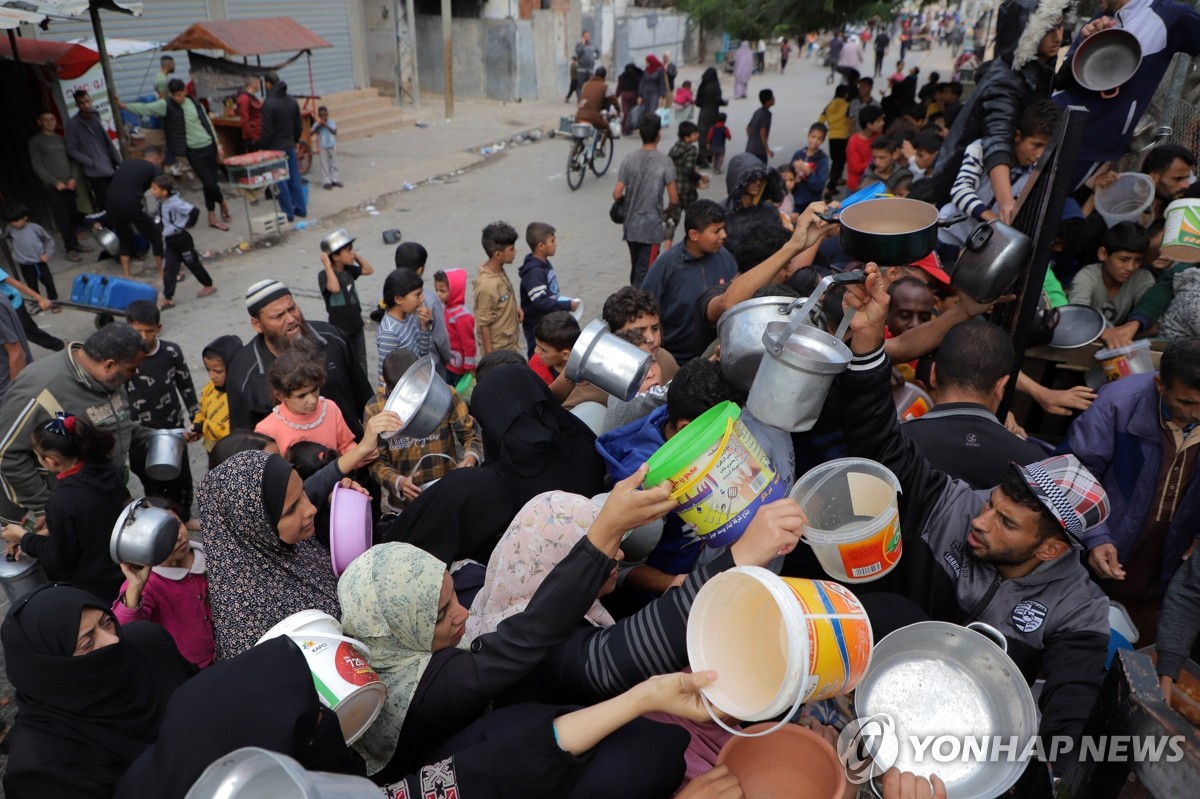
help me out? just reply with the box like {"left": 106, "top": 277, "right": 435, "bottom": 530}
{"left": 822, "top": 197, "right": 967, "bottom": 266}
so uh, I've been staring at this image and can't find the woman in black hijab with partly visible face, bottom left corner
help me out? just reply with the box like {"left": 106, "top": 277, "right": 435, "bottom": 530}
{"left": 0, "top": 584, "right": 196, "bottom": 799}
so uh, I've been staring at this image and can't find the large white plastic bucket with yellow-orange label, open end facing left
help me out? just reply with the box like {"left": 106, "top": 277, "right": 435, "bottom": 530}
{"left": 688, "top": 566, "right": 874, "bottom": 737}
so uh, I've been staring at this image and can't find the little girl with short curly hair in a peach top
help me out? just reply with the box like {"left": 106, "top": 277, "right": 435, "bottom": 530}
{"left": 254, "top": 347, "right": 354, "bottom": 457}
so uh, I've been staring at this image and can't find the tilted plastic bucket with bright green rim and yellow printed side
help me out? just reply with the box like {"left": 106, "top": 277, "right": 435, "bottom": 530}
{"left": 646, "top": 402, "right": 786, "bottom": 547}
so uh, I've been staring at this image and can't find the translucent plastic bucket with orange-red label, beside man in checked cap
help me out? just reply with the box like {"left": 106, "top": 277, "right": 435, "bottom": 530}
{"left": 792, "top": 458, "right": 904, "bottom": 583}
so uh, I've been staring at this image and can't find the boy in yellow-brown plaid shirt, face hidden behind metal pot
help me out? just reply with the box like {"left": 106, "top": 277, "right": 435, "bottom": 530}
{"left": 362, "top": 347, "right": 484, "bottom": 513}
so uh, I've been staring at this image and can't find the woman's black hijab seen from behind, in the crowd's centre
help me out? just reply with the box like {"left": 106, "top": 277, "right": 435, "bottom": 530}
{"left": 470, "top": 364, "right": 605, "bottom": 507}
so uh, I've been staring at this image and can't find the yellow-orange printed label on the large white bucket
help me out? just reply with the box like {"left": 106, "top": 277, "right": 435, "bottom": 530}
{"left": 782, "top": 577, "right": 874, "bottom": 702}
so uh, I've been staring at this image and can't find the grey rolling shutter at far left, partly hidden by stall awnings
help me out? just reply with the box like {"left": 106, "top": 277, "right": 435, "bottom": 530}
{"left": 36, "top": 0, "right": 209, "bottom": 100}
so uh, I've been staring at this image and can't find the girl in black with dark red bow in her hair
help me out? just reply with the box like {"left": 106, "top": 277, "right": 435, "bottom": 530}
{"left": 4, "top": 411, "right": 130, "bottom": 602}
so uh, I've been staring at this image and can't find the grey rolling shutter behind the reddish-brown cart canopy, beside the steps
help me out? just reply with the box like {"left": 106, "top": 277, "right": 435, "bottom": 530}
{"left": 224, "top": 0, "right": 354, "bottom": 95}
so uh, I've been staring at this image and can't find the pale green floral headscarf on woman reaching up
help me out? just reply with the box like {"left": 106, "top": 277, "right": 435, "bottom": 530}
{"left": 337, "top": 542, "right": 467, "bottom": 774}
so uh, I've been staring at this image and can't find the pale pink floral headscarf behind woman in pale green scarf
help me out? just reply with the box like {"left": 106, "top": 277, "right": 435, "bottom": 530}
{"left": 467, "top": 491, "right": 614, "bottom": 638}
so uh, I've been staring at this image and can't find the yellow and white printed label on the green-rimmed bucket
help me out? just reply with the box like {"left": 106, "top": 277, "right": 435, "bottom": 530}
{"left": 671, "top": 421, "right": 787, "bottom": 546}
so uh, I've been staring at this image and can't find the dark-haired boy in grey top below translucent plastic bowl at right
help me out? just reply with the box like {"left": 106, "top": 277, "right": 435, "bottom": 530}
{"left": 1067, "top": 222, "right": 1154, "bottom": 325}
